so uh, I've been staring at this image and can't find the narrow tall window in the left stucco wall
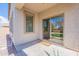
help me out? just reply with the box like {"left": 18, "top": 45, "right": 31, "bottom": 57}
{"left": 26, "top": 16, "right": 33, "bottom": 32}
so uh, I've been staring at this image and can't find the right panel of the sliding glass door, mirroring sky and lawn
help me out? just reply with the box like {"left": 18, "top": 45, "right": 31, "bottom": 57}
{"left": 50, "top": 16, "right": 64, "bottom": 42}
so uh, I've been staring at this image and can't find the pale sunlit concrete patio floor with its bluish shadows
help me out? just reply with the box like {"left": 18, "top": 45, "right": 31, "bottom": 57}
{"left": 0, "top": 27, "right": 79, "bottom": 56}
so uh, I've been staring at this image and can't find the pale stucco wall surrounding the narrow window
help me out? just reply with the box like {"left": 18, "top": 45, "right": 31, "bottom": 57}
{"left": 13, "top": 8, "right": 39, "bottom": 45}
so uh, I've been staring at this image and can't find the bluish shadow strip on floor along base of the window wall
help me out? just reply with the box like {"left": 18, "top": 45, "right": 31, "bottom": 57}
{"left": 16, "top": 40, "right": 41, "bottom": 56}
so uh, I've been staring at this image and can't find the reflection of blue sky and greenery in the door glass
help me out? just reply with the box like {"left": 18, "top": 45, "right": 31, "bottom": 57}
{"left": 50, "top": 17, "right": 64, "bottom": 39}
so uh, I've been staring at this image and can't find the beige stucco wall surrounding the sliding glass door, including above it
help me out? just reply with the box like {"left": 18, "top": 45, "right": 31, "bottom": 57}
{"left": 39, "top": 4, "right": 79, "bottom": 51}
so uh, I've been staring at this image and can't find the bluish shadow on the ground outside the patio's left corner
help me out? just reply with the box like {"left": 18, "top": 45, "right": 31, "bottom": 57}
{"left": 6, "top": 34, "right": 27, "bottom": 56}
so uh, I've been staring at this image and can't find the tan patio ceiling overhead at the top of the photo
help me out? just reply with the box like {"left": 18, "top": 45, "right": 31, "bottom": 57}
{"left": 24, "top": 3, "right": 56, "bottom": 13}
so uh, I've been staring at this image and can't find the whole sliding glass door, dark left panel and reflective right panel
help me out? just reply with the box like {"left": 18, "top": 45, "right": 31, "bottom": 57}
{"left": 43, "top": 15, "right": 64, "bottom": 43}
